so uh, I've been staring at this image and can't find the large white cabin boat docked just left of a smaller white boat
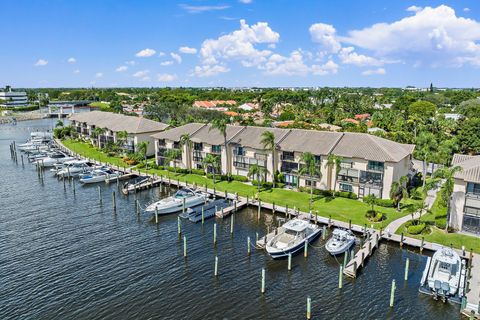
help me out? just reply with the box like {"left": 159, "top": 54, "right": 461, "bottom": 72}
{"left": 265, "top": 219, "right": 321, "bottom": 259}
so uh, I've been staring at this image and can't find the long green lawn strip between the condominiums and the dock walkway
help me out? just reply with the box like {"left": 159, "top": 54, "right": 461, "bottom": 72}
{"left": 63, "top": 140, "right": 418, "bottom": 229}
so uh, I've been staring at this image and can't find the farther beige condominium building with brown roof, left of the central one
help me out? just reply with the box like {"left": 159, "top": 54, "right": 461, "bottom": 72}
{"left": 69, "top": 111, "right": 168, "bottom": 156}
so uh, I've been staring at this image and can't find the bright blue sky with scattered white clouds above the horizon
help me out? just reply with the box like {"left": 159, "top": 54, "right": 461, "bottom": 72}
{"left": 0, "top": 0, "right": 480, "bottom": 87}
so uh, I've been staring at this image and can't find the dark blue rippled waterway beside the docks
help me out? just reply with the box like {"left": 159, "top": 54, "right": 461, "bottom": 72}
{"left": 0, "top": 120, "right": 459, "bottom": 319}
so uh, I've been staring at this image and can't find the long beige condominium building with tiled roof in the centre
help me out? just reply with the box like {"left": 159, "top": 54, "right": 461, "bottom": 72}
{"left": 154, "top": 123, "right": 415, "bottom": 198}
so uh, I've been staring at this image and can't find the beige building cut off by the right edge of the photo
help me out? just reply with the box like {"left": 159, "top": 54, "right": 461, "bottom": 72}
{"left": 449, "top": 154, "right": 480, "bottom": 233}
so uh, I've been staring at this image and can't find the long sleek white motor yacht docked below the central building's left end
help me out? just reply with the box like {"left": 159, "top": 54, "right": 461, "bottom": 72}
{"left": 145, "top": 188, "right": 208, "bottom": 214}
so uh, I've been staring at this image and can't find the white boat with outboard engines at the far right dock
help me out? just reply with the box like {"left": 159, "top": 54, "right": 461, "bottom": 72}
{"left": 420, "top": 247, "right": 466, "bottom": 302}
